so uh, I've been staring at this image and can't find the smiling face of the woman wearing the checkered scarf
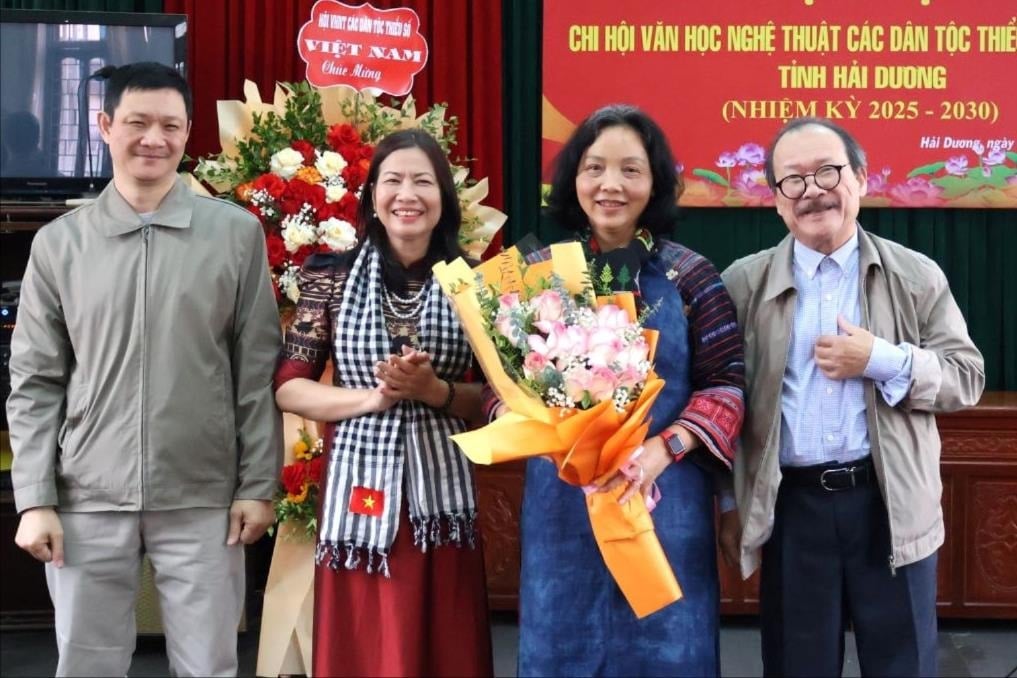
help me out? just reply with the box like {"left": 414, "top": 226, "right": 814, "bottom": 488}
{"left": 373, "top": 147, "right": 441, "bottom": 253}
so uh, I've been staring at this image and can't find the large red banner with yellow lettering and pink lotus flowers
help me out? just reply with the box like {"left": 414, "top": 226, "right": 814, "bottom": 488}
{"left": 542, "top": 0, "right": 1017, "bottom": 208}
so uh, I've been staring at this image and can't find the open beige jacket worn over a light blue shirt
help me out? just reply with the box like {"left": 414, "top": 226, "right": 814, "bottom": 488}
{"left": 722, "top": 228, "right": 985, "bottom": 578}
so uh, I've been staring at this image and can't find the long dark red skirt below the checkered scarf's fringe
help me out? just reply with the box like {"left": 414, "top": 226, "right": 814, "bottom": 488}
{"left": 312, "top": 511, "right": 494, "bottom": 678}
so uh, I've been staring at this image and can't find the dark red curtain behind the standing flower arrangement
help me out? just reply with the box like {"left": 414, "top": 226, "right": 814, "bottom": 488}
{"left": 164, "top": 0, "right": 503, "bottom": 207}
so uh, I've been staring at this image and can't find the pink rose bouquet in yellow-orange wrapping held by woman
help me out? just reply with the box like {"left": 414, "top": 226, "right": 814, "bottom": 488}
{"left": 434, "top": 243, "right": 681, "bottom": 618}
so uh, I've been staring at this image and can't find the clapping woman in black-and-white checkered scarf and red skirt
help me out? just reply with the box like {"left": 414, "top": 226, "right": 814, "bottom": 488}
{"left": 276, "top": 129, "right": 493, "bottom": 676}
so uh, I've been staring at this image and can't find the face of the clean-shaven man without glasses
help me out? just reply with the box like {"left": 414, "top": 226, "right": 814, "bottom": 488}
{"left": 99, "top": 88, "right": 190, "bottom": 188}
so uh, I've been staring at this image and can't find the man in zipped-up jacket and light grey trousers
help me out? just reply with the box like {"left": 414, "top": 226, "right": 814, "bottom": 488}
{"left": 7, "top": 63, "right": 282, "bottom": 676}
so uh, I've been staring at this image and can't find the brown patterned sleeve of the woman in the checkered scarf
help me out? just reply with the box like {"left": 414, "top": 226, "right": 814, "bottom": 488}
{"left": 274, "top": 260, "right": 346, "bottom": 389}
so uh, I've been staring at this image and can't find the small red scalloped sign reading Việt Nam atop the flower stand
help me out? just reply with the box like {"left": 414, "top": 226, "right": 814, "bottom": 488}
{"left": 297, "top": 0, "right": 427, "bottom": 97}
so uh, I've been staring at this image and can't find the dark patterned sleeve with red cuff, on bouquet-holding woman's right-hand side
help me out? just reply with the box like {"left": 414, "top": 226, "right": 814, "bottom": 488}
{"left": 668, "top": 245, "right": 745, "bottom": 469}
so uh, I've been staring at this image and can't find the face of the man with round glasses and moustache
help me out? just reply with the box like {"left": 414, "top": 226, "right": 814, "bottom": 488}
{"left": 773, "top": 125, "right": 868, "bottom": 254}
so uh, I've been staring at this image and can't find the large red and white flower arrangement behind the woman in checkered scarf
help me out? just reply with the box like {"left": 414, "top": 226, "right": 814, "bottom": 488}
{"left": 192, "top": 80, "right": 505, "bottom": 313}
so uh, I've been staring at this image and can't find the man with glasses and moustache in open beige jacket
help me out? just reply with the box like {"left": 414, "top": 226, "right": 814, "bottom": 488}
{"left": 723, "top": 118, "right": 984, "bottom": 676}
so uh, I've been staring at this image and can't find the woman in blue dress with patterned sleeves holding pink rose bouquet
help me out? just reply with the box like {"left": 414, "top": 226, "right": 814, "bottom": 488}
{"left": 502, "top": 105, "right": 744, "bottom": 676}
